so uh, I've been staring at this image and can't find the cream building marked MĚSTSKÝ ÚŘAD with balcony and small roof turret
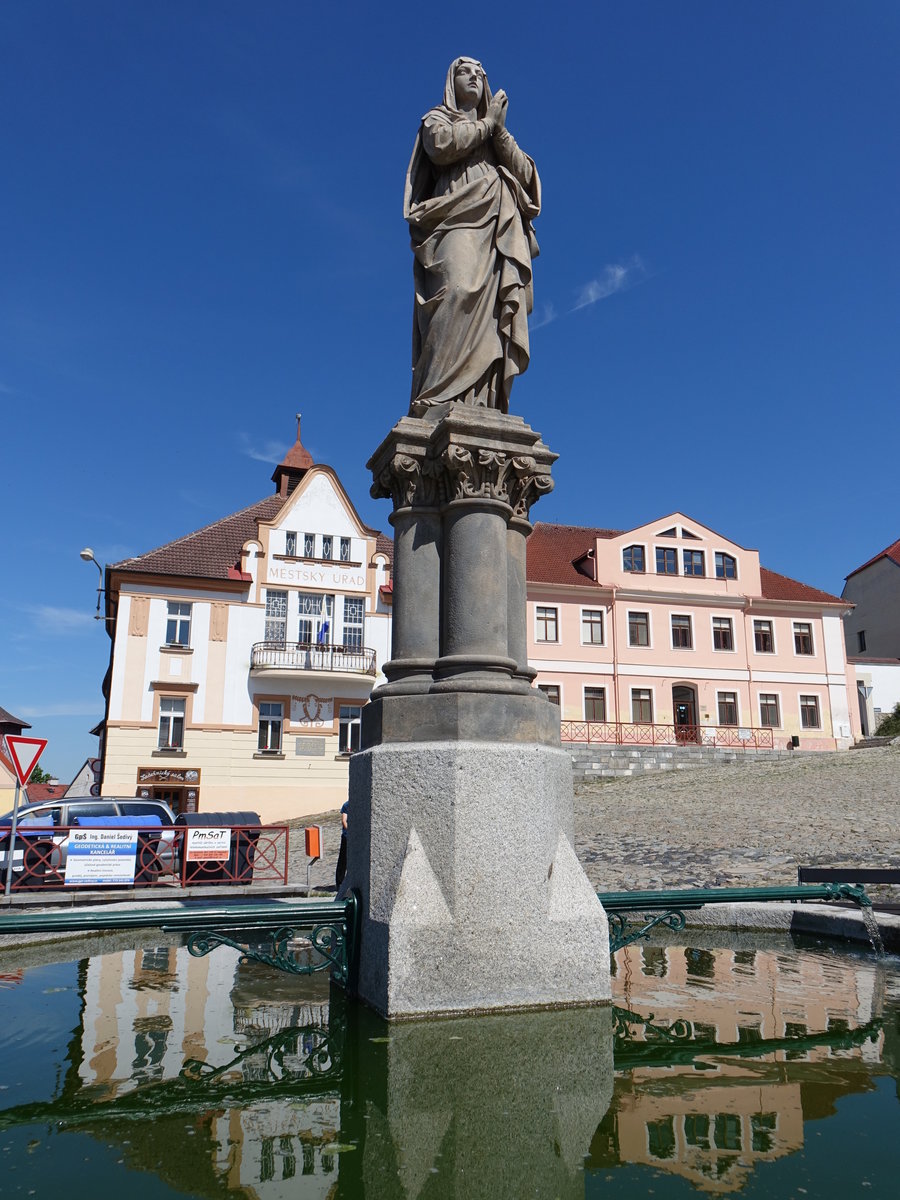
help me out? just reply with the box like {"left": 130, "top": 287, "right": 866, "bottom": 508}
{"left": 102, "top": 427, "right": 391, "bottom": 822}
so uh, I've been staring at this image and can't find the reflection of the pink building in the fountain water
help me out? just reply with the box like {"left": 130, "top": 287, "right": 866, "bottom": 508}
{"left": 600, "top": 944, "right": 898, "bottom": 1193}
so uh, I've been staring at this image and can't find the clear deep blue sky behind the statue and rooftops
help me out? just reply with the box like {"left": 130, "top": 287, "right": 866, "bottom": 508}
{"left": 0, "top": 0, "right": 900, "bottom": 779}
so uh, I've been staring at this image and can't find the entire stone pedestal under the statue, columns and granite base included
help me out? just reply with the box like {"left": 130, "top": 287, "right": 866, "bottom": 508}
{"left": 344, "top": 403, "right": 610, "bottom": 1018}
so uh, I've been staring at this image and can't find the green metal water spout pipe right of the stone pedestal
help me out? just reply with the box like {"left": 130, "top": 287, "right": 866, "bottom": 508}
{"left": 598, "top": 883, "right": 872, "bottom": 954}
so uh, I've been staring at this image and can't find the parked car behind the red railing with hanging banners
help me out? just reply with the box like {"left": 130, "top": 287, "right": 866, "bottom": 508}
{"left": 0, "top": 796, "right": 176, "bottom": 880}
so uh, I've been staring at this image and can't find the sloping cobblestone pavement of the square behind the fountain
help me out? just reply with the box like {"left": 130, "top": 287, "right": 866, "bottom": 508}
{"left": 297, "top": 746, "right": 900, "bottom": 902}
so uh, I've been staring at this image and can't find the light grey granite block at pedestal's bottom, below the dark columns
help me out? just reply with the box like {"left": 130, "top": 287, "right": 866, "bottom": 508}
{"left": 344, "top": 742, "right": 610, "bottom": 1018}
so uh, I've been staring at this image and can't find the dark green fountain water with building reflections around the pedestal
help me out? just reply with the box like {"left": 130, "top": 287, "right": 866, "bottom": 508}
{"left": 0, "top": 935, "right": 900, "bottom": 1200}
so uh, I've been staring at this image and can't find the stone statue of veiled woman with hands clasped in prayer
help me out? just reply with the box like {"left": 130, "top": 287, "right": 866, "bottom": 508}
{"left": 403, "top": 58, "right": 540, "bottom": 416}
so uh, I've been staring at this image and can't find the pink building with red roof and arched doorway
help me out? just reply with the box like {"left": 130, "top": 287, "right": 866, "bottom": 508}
{"left": 528, "top": 512, "right": 859, "bottom": 750}
